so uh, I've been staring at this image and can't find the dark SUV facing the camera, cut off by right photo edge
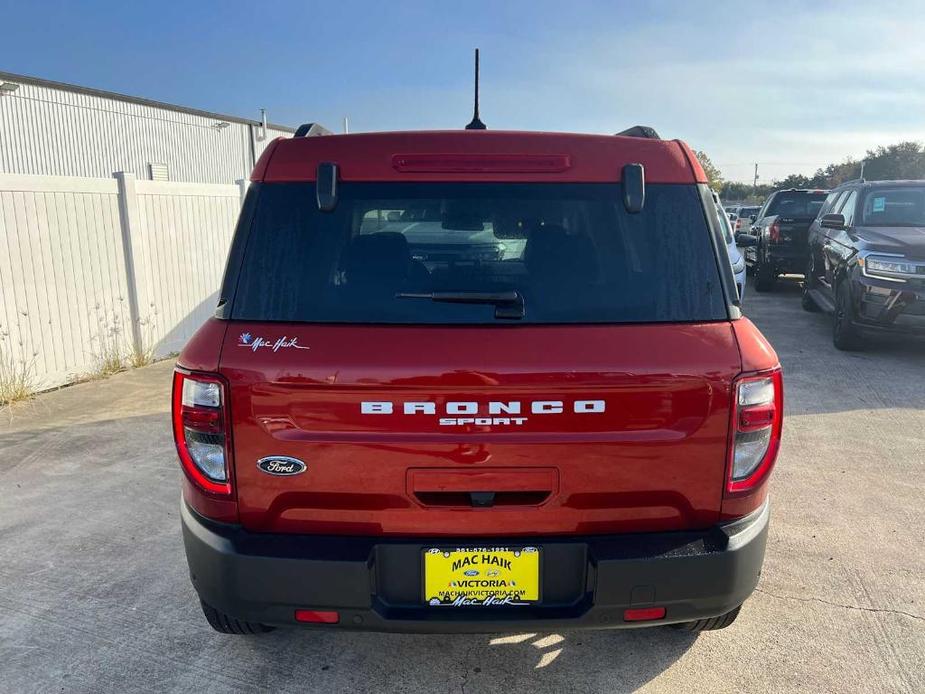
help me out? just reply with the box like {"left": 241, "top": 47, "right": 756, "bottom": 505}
{"left": 803, "top": 180, "right": 925, "bottom": 350}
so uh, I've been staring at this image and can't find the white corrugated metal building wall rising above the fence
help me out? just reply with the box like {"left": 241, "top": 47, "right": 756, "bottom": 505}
{"left": 0, "top": 75, "right": 291, "bottom": 183}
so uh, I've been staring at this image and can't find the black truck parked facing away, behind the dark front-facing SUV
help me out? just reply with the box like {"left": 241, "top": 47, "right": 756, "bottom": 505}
{"left": 739, "top": 188, "right": 828, "bottom": 292}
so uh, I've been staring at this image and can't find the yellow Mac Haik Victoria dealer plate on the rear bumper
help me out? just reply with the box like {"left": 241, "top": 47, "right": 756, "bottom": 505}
{"left": 424, "top": 547, "right": 540, "bottom": 607}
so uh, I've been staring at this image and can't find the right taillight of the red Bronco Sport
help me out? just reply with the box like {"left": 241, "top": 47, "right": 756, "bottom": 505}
{"left": 726, "top": 368, "right": 784, "bottom": 494}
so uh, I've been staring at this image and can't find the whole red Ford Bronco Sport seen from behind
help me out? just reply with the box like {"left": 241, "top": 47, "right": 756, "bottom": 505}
{"left": 173, "top": 128, "right": 783, "bottom": 633}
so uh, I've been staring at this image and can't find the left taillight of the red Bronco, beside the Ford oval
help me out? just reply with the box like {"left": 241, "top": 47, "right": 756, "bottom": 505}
{"left": 173, "top": 369, "right": 231, "bottom": 496}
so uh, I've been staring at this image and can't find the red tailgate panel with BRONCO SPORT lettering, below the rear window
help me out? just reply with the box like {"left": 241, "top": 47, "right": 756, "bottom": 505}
{"left": 221, "top": 321, "right": 740, "bottom": 536}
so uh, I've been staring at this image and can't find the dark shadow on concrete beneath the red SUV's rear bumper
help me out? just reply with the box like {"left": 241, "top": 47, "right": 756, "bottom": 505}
{"left": 235, "top": 627, "right": 697, "bottom": 692}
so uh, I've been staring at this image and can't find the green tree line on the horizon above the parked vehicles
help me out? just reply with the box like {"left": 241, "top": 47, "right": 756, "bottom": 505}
{"left": 696, "top": 142, "right": 925, "bottom": 203}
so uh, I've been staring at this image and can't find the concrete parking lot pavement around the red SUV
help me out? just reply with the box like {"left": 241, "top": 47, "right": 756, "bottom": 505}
{"left": 0, "top": 282, "right": 925, "bottom": 693}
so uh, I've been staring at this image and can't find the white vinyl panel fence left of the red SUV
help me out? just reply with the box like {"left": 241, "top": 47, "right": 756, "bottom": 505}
{"left": 0, "top": 173, "right": 246, "bottom": 387}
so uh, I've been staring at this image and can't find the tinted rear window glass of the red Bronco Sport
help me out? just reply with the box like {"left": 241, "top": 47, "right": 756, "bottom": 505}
{"left": 231, "top": 183, "right": 727, "bottom": 324}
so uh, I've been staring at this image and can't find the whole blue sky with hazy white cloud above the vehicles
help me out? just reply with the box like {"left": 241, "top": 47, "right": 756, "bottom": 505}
{"left": 0, "top": 0, "right": 925, "bottom": 181}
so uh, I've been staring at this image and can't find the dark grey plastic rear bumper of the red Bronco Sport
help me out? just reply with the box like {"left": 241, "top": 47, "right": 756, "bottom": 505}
{"left": 181, "top": 503, "right": 770, "bottom": 633}
